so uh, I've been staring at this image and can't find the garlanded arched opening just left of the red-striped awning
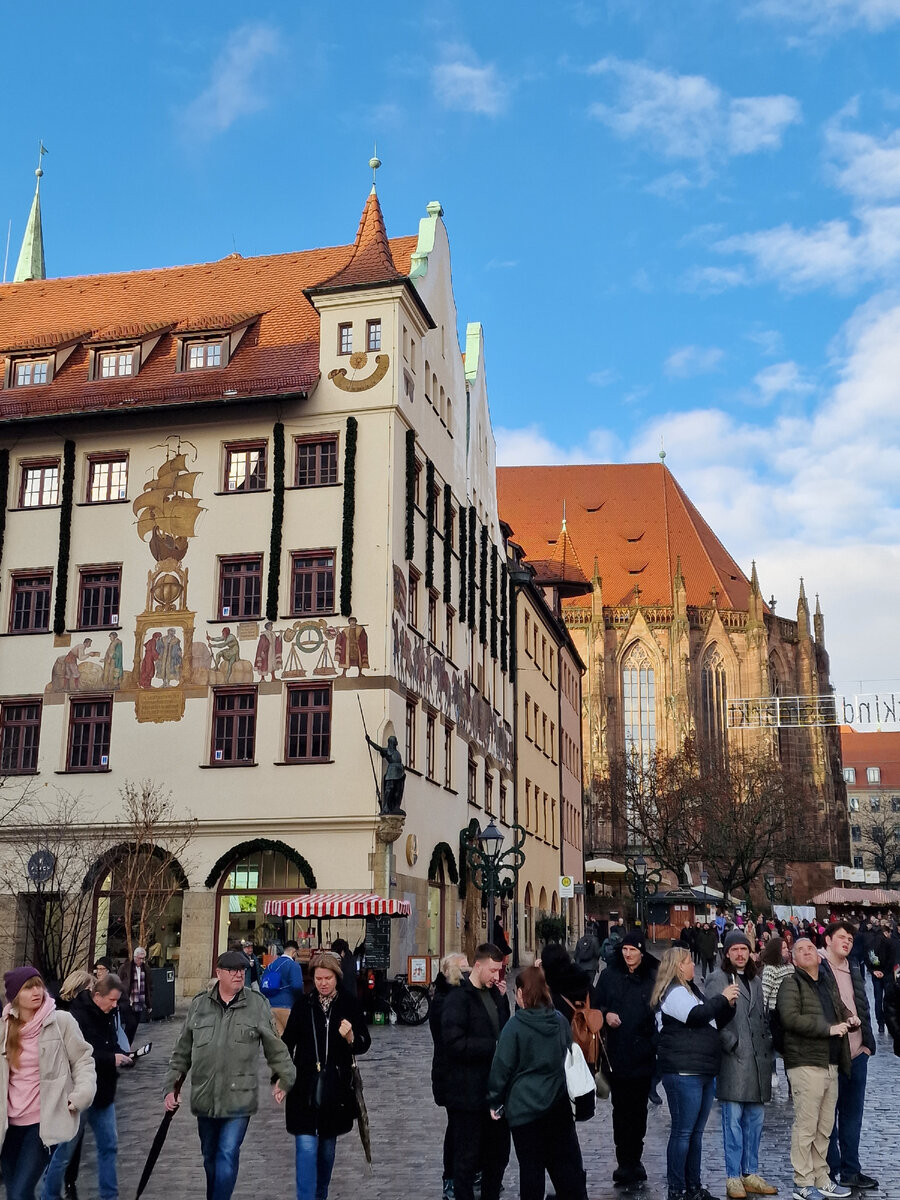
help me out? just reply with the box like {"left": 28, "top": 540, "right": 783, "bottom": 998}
{"left": 206, "top": 838, "right": 316, "bottom": 954}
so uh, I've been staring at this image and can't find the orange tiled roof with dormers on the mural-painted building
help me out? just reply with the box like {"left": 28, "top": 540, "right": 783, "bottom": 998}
{"left": 0, "top": 213, "right": 416, "bottom": 420}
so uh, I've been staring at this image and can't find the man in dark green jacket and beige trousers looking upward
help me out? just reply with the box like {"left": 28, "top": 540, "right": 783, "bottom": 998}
{"left": 776, "top": 937, "right": 859, "bottom": 1200}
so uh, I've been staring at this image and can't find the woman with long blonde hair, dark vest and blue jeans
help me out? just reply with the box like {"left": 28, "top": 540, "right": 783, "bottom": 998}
{"left": 650, "top": 949, "right": 738, "bottom": 1200}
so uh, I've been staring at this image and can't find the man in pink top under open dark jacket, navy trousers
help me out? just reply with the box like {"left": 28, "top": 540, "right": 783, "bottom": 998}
{"left": 821, "top": 920, "right": 878, "bottom": 1190}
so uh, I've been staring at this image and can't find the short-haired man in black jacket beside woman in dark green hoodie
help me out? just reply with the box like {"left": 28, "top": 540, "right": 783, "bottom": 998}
{"left": 440, "top": 942, "right": 510, "bottom": 1200}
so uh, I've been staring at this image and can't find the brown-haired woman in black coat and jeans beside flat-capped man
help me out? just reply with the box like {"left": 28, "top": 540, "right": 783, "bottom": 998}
{"left": 276, "top": 952, "right": 372, "bottom": 1200}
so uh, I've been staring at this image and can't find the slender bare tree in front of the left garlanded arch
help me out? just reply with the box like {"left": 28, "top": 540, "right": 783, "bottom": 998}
{"left": 107, "top": 779, "right": 197, "bottom": 958}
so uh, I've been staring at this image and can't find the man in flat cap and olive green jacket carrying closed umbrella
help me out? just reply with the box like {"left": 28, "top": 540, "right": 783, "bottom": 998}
{"left": 166, "top": 950, "right": 296, "bottom": 1200}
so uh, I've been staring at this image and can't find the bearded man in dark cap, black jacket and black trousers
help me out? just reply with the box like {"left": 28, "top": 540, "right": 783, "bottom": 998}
{"left": 590, "top": 932, "right": 659, "bottom": 1183}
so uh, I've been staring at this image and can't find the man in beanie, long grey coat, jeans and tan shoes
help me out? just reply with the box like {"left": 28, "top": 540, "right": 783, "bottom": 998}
{"left": 706, "top": 929, "right": 778, "bottom": 1200}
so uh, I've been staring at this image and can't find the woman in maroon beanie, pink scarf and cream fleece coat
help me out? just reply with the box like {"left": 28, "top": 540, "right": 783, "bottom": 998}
{"left": 0, "top": 966, "right": 97, "bottom": 1200}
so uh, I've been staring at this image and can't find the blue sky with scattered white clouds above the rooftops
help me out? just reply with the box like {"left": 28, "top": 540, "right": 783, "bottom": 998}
{"left": 0, "top": 0, "right": 900, "bottom": 690}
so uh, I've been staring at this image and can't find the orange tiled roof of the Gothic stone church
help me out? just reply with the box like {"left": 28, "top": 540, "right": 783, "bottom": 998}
{"left": 497, "top": 463, "right": 750, "bottom": 612}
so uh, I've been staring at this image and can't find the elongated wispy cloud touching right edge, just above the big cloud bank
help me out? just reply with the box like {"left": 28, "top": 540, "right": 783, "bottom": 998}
{"left": 720, "top": 205, "right": 900, "bottom": 292}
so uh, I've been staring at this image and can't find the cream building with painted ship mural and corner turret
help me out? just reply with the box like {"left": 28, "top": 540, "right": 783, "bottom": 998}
{"left": 0, "top": 187, "right": 535, "bottom": 995}
